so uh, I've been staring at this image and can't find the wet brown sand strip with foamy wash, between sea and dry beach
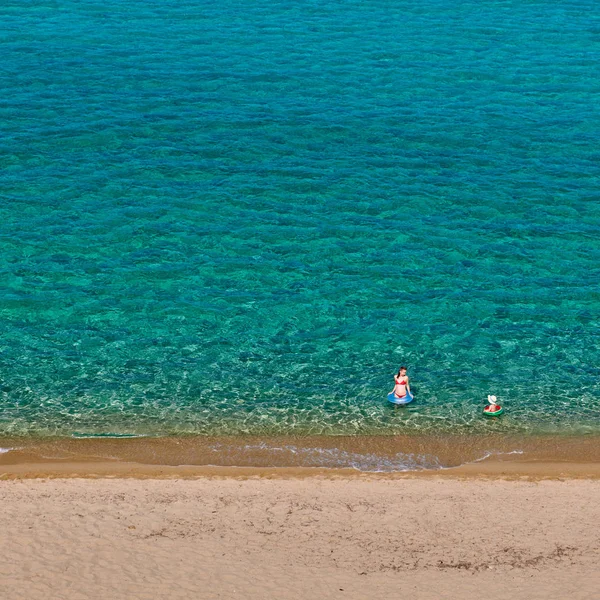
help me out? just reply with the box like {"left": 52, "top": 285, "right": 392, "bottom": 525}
{"left": 0, "top": 436, "right": 600, "bottom": 479}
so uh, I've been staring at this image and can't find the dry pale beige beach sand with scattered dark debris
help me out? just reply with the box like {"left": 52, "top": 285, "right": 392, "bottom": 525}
{"left": 0, "top": 476, "right": 600, "bottom": 600}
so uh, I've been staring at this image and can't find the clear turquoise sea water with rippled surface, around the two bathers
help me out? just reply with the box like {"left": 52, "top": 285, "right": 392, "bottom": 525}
{"left": 0, "top": 0, "right": 600, "bottom": 435}
